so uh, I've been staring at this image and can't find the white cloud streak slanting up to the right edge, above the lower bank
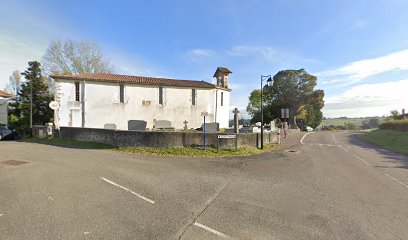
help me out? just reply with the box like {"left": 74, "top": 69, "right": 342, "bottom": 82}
{"left": 317, "top": 49, "right": 408, "bottom": 85}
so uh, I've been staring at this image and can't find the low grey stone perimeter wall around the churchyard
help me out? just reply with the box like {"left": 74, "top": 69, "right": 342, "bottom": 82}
{"left": 59, "top": 127, "right": 277, "bottom": 148}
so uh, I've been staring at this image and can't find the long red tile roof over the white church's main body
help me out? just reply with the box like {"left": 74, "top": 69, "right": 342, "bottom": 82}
{"left": 50, "top": 73, "right": 223, "bottom": 88}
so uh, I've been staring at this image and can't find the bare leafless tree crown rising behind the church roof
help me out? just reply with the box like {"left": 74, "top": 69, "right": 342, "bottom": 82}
{"left": 43, "top": 40, "right": 112, "bottom": 74}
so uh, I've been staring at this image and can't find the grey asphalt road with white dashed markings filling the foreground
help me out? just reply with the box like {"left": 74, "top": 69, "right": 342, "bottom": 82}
{"left": 0, "top": 132, "right": 408, "bottom": 240}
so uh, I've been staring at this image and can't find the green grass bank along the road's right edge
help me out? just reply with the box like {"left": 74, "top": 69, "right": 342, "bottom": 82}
{"left": 356, "top": 129, "right": 408, "bottom": 156}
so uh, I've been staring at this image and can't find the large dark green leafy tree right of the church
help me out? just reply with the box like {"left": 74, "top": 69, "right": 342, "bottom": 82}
{"left": 247, "top": 69, "right": 324, "bottom": 128}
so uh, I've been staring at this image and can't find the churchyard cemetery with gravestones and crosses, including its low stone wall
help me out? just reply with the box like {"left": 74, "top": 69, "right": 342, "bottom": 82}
{"left": 52, "top": 109, "right": 292, "bottom": 149}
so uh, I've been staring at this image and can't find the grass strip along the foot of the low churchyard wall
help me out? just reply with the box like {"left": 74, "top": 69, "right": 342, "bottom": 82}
{"left": 21, "top": 138, "right": 277, "bottom": 157}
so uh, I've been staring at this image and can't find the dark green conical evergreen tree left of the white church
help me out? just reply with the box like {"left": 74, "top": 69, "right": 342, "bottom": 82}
{"left": 9, "top": 61, "right": 53, "bottom": 134}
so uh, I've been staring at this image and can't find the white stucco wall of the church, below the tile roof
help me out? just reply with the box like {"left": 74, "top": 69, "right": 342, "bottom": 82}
{"left": 55, "top": 79, "right": 230, "bottom": 130}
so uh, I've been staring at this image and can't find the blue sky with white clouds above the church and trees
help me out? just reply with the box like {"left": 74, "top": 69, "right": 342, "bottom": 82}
{"left": 0, "top": 0, "right": 408, "bottom": 117}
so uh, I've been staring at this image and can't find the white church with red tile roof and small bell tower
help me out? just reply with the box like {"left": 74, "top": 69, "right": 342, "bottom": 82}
{"left": 51, "top": 67, "right": 231, "bottom": 130}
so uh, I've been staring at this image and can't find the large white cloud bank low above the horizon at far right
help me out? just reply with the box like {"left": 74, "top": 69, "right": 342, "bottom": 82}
{"left": 323, "top": 79, "right": 408, "bottom": 117}
